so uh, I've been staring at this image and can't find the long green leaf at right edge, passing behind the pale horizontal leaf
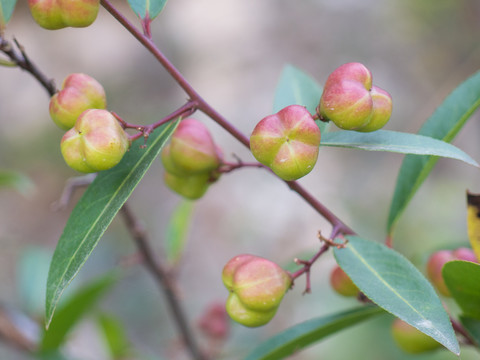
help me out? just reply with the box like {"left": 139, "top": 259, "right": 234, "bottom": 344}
{"left": 387, "top": 72, "right": 480, "bottom": 234}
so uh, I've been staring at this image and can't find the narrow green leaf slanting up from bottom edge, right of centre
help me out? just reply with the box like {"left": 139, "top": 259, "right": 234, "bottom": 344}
{"left": 246, "top": 306, "right": 383, "bottom": 360}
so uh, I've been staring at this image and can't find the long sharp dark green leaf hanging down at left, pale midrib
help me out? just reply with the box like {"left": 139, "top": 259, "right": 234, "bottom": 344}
{"left": 45, "top": 123, "right": 175, "bottom": 326}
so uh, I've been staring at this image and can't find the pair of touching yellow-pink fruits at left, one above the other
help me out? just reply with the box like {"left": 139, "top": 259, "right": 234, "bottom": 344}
{"left": 49, "top": 73, "right": 130, "bottom": 173}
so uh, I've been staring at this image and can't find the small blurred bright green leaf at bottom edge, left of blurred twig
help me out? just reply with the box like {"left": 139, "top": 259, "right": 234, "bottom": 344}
{"left": 98, "top": 314, "right": 131, "bottom": 359}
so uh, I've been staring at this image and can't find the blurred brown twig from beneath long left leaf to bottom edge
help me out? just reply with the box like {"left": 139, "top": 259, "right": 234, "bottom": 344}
{"left": 121, "top": 204, "right": 206, "bottom": 360}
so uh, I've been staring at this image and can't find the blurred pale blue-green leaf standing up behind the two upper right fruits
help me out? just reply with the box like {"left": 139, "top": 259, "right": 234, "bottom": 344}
{"left": 273, "top": 65, "right": 328, "bottom": 134}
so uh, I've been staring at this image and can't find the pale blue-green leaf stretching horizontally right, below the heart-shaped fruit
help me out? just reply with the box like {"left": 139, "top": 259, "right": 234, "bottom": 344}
{"left": 321, "top": 130, "right": 479, "bottom": 167}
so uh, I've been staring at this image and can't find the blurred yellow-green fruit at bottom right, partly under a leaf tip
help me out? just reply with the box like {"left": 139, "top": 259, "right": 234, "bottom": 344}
{"left": 391, "top": 318, "right": 441, "bottom": 354}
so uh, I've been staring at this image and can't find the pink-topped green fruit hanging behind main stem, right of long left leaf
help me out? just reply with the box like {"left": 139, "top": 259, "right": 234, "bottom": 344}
{"left": 161, "top": 118, "right": 223, "bottom": 200}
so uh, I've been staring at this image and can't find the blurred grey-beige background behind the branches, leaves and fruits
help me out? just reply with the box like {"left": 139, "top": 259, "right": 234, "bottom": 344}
{"left": 0, "top": 0, "right": 480, "bottom": 360}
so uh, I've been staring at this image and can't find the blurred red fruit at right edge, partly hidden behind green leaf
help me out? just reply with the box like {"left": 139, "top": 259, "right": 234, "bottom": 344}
{"left": 427, "top": 248, "right": 477, "bottom": 297}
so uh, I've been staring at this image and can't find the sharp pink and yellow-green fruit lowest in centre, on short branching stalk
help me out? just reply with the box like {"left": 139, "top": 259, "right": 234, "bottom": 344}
{"left": 222, "top": 254, "right": 292, "bottom": 327}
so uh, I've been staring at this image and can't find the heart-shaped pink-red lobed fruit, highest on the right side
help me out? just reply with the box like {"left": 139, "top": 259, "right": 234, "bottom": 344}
{"left": 318, "top": 63, "right": 392, "bottom": 132}
